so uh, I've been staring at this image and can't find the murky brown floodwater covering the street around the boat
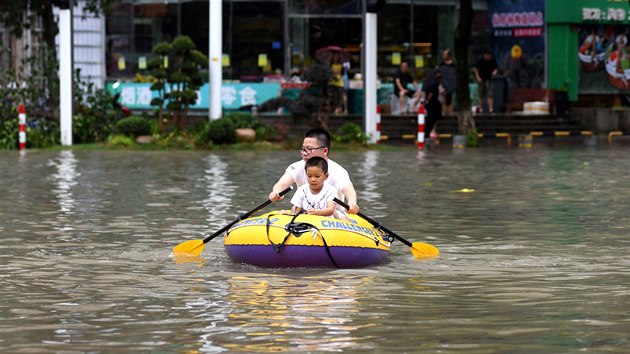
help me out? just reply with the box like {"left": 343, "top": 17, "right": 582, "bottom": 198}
{"left": 0, "top": 146, "right": 630, "bottom": 353}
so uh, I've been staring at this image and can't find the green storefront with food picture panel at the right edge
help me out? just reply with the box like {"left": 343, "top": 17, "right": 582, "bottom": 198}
{"left": 545, "top": 0, "right": 630, "bottom": 101}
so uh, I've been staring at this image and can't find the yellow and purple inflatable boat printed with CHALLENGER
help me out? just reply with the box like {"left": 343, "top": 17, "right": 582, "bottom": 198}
{"left": 224, "top": 212, "right": 393, "bottom": 268}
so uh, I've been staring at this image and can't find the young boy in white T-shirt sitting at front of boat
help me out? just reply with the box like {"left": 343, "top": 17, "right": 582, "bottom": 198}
{"left": 291, "top": 156, "right": 337, "bottom": 216}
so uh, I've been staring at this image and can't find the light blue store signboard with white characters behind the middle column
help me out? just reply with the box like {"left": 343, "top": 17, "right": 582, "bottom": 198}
{"left": 108, "top": 83, "right": 281, "bottom": 109}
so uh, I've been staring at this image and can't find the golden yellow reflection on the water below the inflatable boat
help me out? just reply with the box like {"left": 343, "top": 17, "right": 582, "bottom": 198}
{"left": 195, "top": 274, "right": 372, "bottom": 353}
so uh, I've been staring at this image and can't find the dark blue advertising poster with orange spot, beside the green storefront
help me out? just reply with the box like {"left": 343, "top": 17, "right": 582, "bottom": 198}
{"left": 488, "top": 0, "right": 545, "bottom": 89}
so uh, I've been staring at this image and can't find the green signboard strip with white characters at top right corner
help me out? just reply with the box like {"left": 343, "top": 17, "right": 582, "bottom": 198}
{"left": 547, "top": 0, "right": 630, "bottom": 25}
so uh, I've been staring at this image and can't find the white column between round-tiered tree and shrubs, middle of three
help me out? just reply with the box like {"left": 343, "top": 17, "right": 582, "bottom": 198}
{"left": 208, "top": 0, "right": 223, "bottom": 119}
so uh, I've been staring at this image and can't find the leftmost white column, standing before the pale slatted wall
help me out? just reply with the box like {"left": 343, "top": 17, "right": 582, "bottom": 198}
{"left": 59, "top": 9, "right": 72, "bottom": 146}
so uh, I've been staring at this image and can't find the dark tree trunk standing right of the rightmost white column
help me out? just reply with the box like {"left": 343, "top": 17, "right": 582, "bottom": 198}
{"left": 455, "top": 0, "right": 477, "bottom": 145}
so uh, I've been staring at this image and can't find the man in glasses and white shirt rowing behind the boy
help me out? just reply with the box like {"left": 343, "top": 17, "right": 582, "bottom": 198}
{"left": 269, "top": 128, "right": 359, "bottom": 214}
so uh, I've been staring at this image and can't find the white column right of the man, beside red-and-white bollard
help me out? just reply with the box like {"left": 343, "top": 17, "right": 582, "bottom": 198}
{"left": 363, "top": 12, "right": 377, "bottom": 144}
